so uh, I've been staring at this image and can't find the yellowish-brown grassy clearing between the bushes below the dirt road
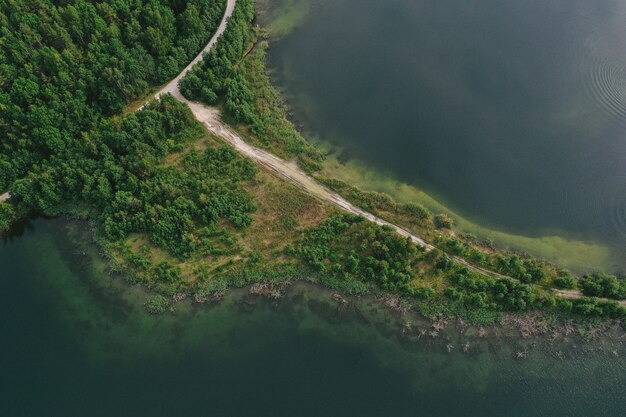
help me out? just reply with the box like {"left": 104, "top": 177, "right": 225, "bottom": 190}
{"left": 106, "top": 132, "right": 334, "bottom": 295}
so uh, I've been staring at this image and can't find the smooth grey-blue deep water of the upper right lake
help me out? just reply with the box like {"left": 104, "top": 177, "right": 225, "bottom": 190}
{"left": 271, "top": 0, "right": 626, "bottom": 267}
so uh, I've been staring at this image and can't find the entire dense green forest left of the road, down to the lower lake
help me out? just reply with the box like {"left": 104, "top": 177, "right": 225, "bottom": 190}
{"left": 0, "top": 0, "right": 256, "bottom": 270}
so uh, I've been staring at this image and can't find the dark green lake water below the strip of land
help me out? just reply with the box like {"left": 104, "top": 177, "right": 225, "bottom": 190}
{"left": 0, "top": 220, "right": 626, "bottom": 417}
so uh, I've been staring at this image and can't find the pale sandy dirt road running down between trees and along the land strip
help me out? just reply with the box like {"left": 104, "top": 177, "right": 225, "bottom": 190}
{"left": 151, "top": 0, "right": 626, "bottom": 306}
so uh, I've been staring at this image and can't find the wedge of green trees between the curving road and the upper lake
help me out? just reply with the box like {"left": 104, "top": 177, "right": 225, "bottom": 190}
{"left": 180, "top": 0, "right": 322, "bottom": 171}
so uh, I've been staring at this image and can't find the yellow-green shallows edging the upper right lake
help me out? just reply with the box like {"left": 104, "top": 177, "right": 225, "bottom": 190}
{"left": 260, "top": 6, "right": 626, "bottom": 274}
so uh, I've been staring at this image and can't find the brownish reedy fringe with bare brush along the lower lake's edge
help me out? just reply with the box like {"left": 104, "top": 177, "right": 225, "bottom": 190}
{"left": 172, "top": 278, "right": 626, "bottom": 359}
